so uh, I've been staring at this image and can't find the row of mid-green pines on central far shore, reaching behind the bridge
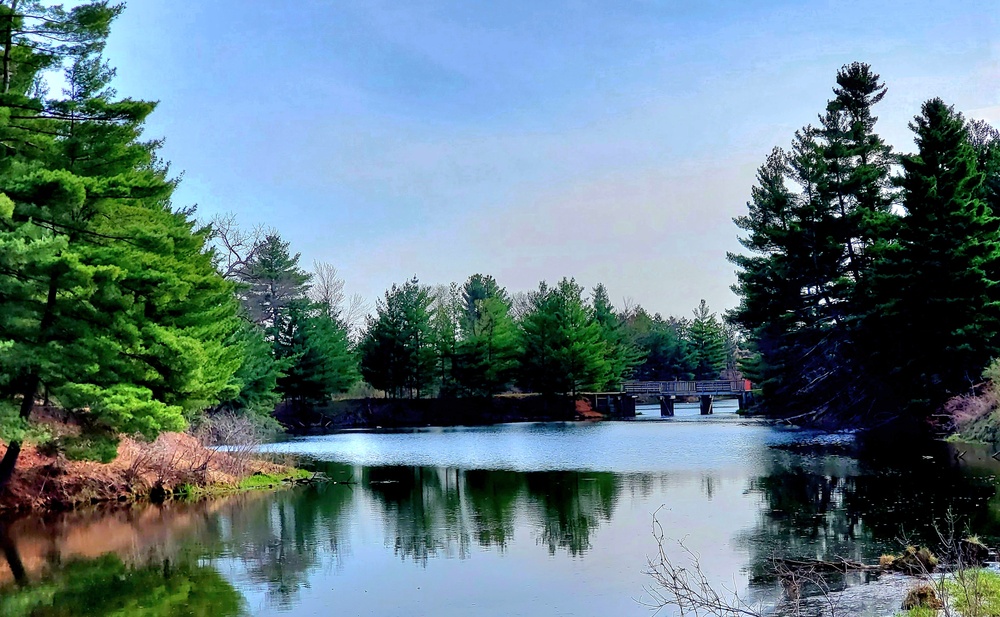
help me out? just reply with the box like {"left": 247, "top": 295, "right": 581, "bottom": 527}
{"left": 358, "top": 274, "right": 743, "bottom": 398}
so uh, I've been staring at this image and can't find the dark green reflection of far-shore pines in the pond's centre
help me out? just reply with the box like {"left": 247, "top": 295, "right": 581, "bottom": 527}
{"left": 362, "top": 467, "right": 622, "bottom": 563}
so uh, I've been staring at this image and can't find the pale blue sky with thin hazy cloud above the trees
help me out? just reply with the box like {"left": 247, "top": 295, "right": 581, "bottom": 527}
{"left": 107, "top": 0, "right": 1000, "bottom": 315}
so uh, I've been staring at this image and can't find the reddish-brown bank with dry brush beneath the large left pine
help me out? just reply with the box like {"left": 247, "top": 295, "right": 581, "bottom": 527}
{"left": 0, "top": 433, "right": 288, "bottom": 512}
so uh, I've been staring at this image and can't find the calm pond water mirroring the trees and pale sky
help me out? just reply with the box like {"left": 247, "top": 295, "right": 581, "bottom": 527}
{"left": 0, "top": 406, "right": 1000, "bottom": 617}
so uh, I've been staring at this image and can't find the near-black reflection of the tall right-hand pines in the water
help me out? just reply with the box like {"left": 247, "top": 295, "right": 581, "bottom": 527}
{"left": 736, "top": 451, "right": 997, "bottom": 580}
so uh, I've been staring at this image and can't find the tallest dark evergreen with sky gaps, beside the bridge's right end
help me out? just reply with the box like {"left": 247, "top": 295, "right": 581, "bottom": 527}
{"left": 728, "top": 63, "right": 895, "bottom": 413}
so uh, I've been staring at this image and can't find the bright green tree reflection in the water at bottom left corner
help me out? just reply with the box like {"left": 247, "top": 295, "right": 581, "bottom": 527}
{"left": 0, "top": 555, "right": 244, "bottom": 617}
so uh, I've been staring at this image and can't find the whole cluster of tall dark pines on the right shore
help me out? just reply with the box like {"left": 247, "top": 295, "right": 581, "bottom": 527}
{"left": 728, "top": 63, "right": 1000, "bottom": 422}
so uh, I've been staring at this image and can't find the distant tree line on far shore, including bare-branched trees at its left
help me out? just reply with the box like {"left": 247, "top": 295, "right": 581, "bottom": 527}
{"left": 214, "top": 224, "right": 740, "bottom": 406}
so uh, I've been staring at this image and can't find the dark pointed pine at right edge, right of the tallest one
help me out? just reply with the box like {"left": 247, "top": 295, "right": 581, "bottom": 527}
{"left": 865, "top": 99, "right": 1000, "bottom": 412}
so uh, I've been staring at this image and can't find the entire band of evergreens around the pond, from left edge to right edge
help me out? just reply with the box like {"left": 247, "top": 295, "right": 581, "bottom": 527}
{"left": 0, "top": 0, "right": 1000, "bottom": 484}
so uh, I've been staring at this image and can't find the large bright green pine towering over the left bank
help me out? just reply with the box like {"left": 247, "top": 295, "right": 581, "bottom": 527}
{"left": 0, "top": 2, "right": 239, "bottom": 486}
